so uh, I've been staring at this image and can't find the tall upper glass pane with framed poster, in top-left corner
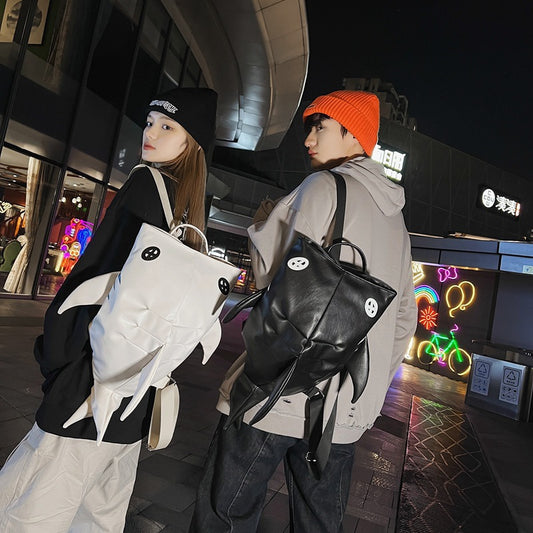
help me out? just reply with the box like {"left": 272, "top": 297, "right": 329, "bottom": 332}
{"left": 6, "top": 0, "right": 98, "bottom": 161}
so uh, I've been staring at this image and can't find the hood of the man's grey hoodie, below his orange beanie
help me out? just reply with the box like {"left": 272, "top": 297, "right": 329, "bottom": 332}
{"left": 332, "top": 157, "right": 405, "bottom": 217}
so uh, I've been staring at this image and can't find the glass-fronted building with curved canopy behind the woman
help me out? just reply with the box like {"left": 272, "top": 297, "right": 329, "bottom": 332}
{"left": 0, "top": 0, "right": 308, "bottom": 298}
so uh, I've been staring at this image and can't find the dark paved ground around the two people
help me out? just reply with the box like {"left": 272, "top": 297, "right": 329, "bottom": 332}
{"left": 0, "top": 300, "right": 533, "bottom": 533}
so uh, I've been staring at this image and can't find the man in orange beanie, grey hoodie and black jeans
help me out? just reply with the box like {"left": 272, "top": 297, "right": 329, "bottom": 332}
{"left": 191, "top": 91, "right": 417, "bottom": 533}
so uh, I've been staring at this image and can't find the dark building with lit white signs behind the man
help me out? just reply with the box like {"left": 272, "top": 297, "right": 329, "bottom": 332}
{"left": 213, "top": 86, "right": 533, "bottom": 241}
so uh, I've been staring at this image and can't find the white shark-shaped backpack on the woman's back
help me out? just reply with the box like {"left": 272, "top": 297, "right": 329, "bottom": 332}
{"left": 58, "top": 167, "right": 240, "bottom": 447}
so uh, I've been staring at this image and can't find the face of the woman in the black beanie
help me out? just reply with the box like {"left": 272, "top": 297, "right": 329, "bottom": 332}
{"left": 142, "top": 111, "right": 187, "bottom": 163}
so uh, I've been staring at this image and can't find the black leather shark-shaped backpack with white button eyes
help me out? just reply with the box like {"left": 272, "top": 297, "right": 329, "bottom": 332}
{"left": 227, "top": 236, "right": 396, "bottom": 425}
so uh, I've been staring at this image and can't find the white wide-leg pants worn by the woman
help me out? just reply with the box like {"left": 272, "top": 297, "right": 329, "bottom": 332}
{"left": 0, "top": 424, "right": 141, "bottom": 533}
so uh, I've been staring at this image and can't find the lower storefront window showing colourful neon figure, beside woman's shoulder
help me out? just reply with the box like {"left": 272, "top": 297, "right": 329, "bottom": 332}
{"left": 38, "top": 171, "right": 103, "bottom": 295}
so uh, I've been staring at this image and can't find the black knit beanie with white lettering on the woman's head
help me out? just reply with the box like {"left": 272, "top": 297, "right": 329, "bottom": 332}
{"left": 146, "top": 87, "right": 217, "bottom": 155}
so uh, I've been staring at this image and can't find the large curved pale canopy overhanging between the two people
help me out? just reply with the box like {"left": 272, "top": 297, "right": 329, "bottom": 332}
{"left": 163, "top": 0, "right": 309, "bottom": 150}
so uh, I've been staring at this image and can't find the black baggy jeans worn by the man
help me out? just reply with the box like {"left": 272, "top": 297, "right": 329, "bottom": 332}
{"left": 189, "top": 415, "right": 355, "bottom": 533}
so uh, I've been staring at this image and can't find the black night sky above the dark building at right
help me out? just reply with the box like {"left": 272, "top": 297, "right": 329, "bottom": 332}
{"left": 304, "top": 0, "right": 533, "bottom": 180}
